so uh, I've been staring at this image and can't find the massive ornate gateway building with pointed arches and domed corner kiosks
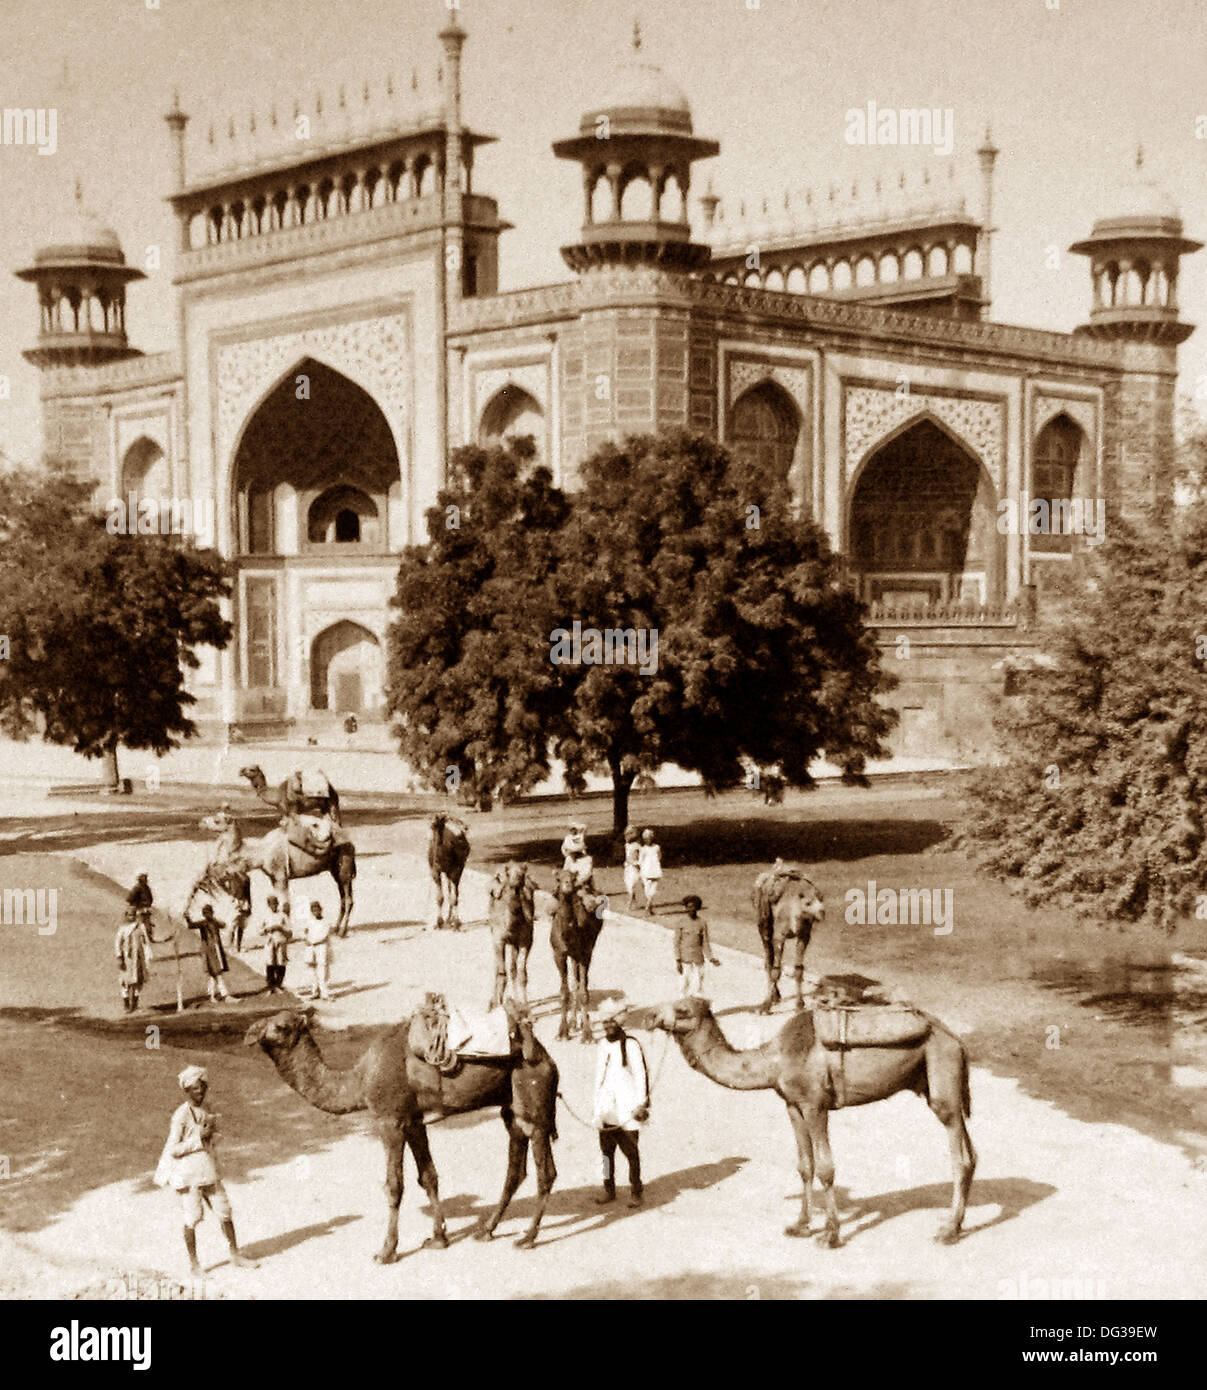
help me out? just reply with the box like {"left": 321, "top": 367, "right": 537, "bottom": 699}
{"left": 17, "top": 19, "right": 1200, "bottom": 753}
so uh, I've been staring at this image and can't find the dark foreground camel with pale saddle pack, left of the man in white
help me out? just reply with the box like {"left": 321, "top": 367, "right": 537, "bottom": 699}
{"left": 245, "top": 1012, "right": 558, "bottom": 1265}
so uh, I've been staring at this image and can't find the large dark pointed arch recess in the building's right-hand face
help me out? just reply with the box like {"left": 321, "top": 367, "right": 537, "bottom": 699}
{"left": 848, "top": 420, "right": 1001, "bottom": 605}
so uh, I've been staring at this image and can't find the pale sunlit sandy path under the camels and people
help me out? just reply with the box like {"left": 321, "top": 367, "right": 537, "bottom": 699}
{"left": 0, "top": 811, "right": 1207, "bottom": 1298}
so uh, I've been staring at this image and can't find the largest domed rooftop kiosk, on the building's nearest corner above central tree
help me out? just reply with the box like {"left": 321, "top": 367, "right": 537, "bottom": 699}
{"left": 553, "top": 25, "right": 720, "bottom": 271}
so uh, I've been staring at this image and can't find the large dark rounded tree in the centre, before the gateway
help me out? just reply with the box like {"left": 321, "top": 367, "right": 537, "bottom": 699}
{"left": 389, "top": 434, "right": 894, "bottom": 833}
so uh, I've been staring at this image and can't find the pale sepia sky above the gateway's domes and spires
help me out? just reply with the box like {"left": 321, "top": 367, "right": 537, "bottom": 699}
{"left": 0, "top": 0, "right": 1207, "bottom": 459}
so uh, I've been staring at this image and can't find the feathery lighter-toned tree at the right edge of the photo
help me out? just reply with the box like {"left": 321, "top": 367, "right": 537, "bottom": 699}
{"left": 961, "top": 469, "right": 1207, "bottom": 930}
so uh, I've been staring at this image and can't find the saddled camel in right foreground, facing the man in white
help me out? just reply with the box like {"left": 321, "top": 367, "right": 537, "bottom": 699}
{"left": 654, "top": 998, "right": 976, "bottom": 1250}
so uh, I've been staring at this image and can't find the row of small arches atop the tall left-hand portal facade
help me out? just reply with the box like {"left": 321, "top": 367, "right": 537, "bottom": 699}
{"left": 189, "top": 153, "right": 442, "bottom": 249}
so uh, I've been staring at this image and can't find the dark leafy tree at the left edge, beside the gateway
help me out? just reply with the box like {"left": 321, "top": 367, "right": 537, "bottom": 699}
{"left": 0, "top": 468, "right": 231, "bottom": 787}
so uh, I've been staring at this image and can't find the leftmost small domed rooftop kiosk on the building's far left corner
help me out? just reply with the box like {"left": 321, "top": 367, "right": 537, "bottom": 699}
{"left": 17, "top": 182, "right": 145, "bottom": 367}
